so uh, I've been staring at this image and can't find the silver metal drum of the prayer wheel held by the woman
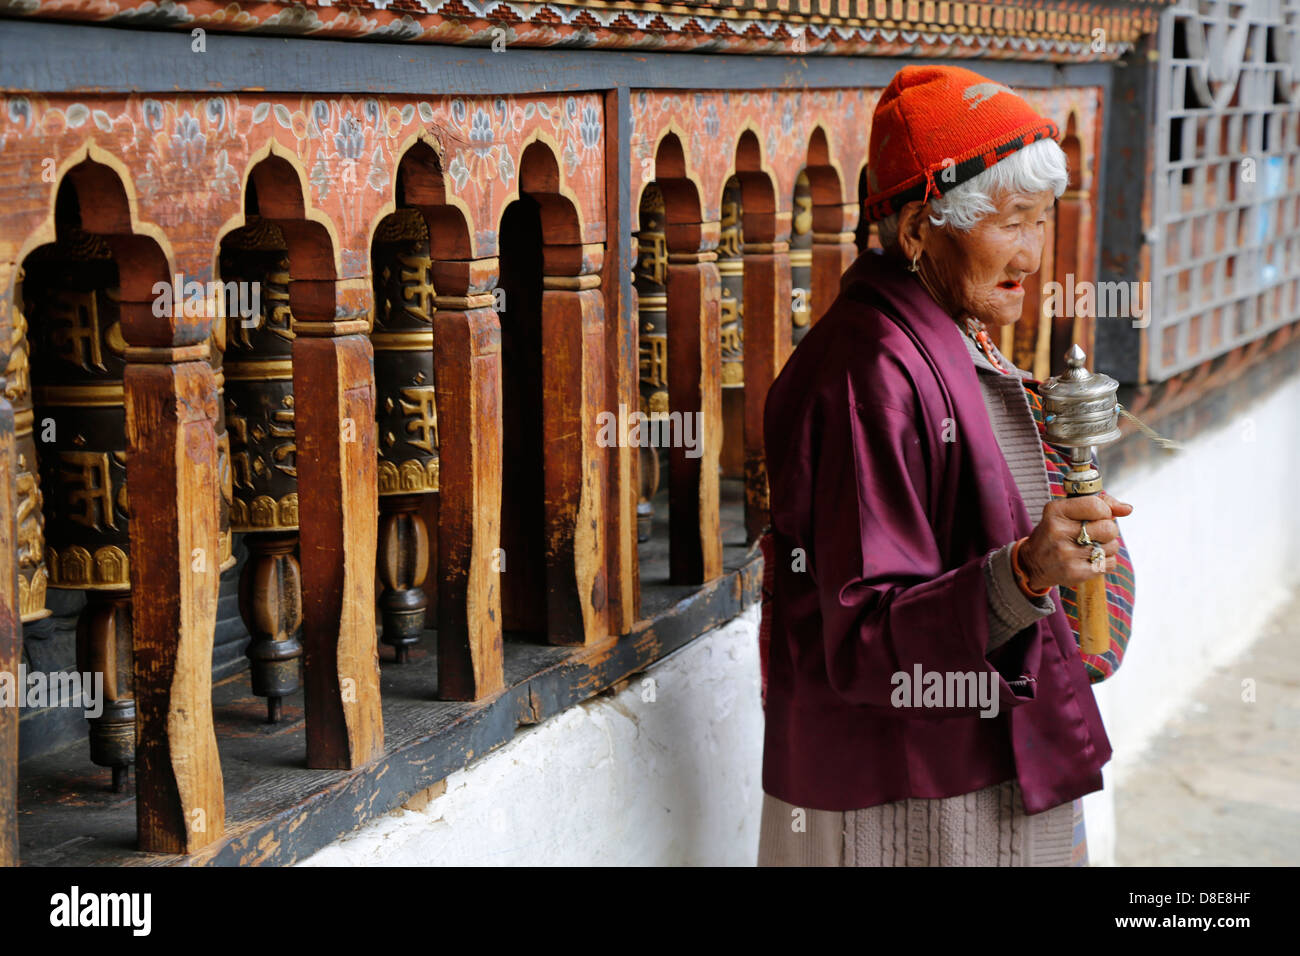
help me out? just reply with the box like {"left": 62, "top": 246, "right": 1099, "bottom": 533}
{"left": 1039, "top": 345, "right": 1121, "bottom": 494}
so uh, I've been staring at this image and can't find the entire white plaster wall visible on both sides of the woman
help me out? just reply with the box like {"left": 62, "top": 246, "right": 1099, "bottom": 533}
{"left": 304, "top": 378, "right": 1300, "bottom": 866}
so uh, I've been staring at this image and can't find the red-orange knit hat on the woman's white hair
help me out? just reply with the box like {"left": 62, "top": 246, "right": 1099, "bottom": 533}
{"left": 862, "top": 66, "right": 1060, "bottom": 222}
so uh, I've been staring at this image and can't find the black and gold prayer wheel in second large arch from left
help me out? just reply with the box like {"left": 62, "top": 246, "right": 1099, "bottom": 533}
{"left": 221, "top": 217, "right": 303, "bottom": 723}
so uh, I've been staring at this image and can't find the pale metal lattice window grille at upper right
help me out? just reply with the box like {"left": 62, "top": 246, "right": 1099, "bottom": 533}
{"left": 1149, "top": 0, "right": 1300, "bottom": 381}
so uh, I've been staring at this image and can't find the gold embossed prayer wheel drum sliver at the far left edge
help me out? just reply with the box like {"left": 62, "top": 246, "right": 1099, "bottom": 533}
{"left": 5, "top": 271, "right": 49, "bottom": 623}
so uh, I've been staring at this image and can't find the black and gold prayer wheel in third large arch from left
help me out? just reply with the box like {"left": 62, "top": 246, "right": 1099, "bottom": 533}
{"left": 371, "top": 208, "right": 438, "bottom": 663}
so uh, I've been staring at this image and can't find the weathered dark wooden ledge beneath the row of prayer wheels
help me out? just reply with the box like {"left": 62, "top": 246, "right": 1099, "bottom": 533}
{"left": 12, "top": 481, "right": 762, "bottom": 865}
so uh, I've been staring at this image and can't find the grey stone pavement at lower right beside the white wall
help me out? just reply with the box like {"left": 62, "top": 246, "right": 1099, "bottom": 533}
{"left": 1115, "top": 591, "right": 1300, "bottom": 866}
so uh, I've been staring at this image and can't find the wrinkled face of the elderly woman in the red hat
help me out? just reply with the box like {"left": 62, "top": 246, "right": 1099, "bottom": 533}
{"left": 923, "top": 190, "right": 1056, "bottom": 328}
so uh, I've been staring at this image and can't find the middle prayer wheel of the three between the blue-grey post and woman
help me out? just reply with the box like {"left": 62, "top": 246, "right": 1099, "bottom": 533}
{"left": 718, "top": 176, "right": 745, "bottom": 477}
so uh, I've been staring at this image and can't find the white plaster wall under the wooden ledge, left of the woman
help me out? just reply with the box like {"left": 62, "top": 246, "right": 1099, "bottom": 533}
{"left": 300, "top": 604, "right": 763, "bottom": 866}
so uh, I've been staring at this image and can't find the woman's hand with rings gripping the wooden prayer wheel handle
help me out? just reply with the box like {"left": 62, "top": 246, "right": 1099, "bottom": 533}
{"left": 1019, "top": 492, "right": 1134, "bottom": 591}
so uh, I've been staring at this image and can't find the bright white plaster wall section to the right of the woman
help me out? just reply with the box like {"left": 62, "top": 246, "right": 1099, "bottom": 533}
{"left": 1084, "top": 378, "right": 1300, "bottom": 865}
